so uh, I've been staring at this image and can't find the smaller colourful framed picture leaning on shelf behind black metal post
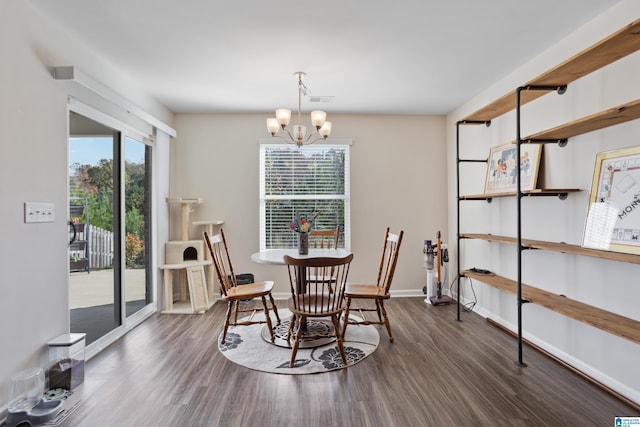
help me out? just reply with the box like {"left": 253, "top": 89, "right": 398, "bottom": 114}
{"left": 484, "top": 143, "right": 542, "bottom": 194}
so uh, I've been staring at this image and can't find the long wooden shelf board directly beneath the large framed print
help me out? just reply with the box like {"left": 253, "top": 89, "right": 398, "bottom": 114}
{"left": 460, "top": 233, "right": 640, "bottom": 264}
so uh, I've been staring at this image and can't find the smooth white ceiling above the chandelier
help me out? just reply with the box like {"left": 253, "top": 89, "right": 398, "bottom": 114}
{"left": 27, "top": 0, "right": 619, "bottom": 114}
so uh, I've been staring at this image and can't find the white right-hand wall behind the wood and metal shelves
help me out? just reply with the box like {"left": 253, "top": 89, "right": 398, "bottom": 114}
{"left": 447, "top": 1, "right": 640, "bottom": 402}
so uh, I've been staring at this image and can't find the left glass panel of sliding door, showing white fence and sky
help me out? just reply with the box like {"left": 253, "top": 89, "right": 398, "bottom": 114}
{"left": 69, "top": 113, "right": 121, "bottom": 344}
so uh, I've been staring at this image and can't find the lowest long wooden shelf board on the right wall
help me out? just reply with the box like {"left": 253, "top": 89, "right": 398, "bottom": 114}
{"left": 460, "top": 270, "right": 640, "bottom": 344}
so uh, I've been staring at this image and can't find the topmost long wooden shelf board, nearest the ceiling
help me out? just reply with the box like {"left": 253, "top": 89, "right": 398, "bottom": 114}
{"left": 462, "top": 19, "right": 640, "bottom": 121}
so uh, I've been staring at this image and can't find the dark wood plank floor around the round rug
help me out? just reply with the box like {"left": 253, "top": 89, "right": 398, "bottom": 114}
{"left": 58, "top": 298, "right": 640, "bottom": 427}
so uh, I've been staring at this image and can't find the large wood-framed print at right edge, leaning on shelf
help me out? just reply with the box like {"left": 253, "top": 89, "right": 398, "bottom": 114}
{"left": 582, "top": 146, "right": 640, "bottom": 254}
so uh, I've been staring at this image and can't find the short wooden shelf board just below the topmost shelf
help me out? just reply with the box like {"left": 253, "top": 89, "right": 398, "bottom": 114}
{"left": 523, "top": 100, "right": 640, "bottom": 142}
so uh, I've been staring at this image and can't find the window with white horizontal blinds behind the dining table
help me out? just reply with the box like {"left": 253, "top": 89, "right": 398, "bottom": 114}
{"left": 260, "top": 143, "right": 351, "bottom": 250}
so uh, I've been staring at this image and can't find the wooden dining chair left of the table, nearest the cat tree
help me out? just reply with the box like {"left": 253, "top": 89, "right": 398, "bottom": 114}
{"left": 202, "top": 230, "right": 280, "bottom": 344}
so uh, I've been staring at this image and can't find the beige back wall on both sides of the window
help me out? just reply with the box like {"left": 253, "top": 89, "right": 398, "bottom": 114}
{"left": 171, "top": 114, "right": 447, "bottom": 296}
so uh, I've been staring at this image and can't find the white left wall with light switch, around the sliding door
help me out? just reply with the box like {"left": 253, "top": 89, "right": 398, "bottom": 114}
{"left": 0, "top": 0, "right": 172, "bottom": 419}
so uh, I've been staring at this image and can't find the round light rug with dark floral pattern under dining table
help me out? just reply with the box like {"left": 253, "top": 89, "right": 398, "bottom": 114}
{"left": 218, "top": 308, "right": 380, "bottom": 375}
